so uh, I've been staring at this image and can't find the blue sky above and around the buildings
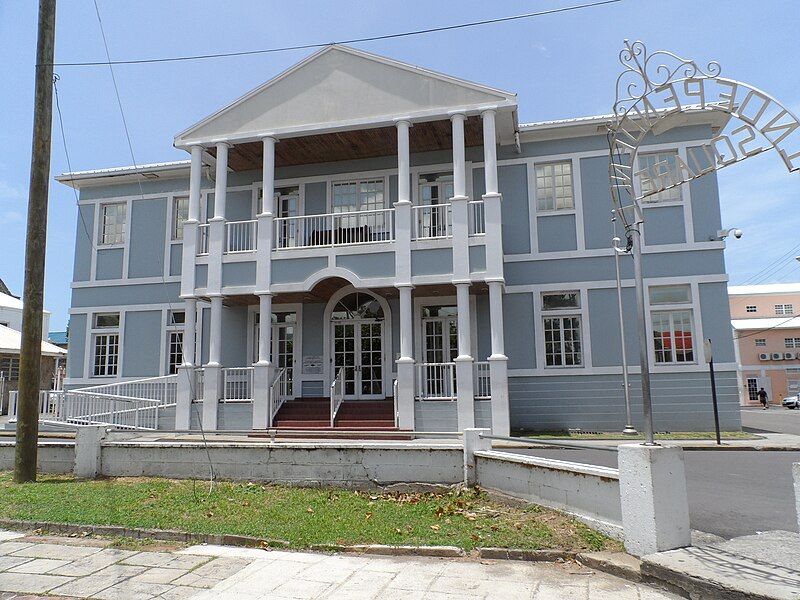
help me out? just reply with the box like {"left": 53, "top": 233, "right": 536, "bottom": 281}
{"left": 0, "top": 0, "right": 800, "bottom": 329}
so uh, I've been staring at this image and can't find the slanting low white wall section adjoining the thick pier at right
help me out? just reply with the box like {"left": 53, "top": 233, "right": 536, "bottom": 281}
{"left": 474, "top": 450, "right": 622, "bottom": 537}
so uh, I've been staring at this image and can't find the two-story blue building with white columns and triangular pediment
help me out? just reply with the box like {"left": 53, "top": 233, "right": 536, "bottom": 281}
{"left": 58, "top": 46, "right": 740, "bottom": 434}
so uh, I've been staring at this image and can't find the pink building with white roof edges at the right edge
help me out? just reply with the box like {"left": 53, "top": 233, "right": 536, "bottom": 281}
{"left": 728, "top": 283, "right": 800, "bottom": 405}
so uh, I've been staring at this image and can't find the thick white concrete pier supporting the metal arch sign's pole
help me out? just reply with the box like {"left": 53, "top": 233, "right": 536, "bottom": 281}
{"left": 617, "top": 444, "right": 692, "bottom": 556}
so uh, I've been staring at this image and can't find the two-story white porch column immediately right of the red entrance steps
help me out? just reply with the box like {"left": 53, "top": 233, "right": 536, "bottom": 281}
{"left": 394, "top": 119, "right": 414, "bottom": 429}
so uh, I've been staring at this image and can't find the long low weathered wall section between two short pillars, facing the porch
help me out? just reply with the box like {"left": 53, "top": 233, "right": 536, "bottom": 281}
{"left": 100, "top": 442, "right": 464, "bottom": 487}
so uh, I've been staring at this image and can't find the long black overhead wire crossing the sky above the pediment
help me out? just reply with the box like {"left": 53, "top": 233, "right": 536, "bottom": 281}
{"left": 53, "top": 0, "right": 623, "bottom": 67}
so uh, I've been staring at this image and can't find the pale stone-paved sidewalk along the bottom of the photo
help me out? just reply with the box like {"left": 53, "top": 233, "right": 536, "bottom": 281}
{"left": 0, "top": 532, "right": 678, "bottom": 600}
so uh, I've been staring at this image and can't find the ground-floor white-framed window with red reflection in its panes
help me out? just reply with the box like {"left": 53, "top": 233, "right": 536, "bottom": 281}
{"left": 649, "top": 285, "right": 695, "bottom": 365}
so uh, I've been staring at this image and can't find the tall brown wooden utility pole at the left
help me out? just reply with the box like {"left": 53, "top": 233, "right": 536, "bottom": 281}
{"left": 14, "top": 0, "right": 56, "bottom": 483}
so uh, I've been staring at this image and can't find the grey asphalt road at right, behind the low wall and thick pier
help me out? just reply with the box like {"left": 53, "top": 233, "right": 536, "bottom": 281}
{"left": 500, "top": 446, "right": 800, "bottom": 538}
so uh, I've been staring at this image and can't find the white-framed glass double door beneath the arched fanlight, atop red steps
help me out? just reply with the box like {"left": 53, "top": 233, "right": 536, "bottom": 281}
{"left": 331, "top": 319, "right": 385, "bottom": 399}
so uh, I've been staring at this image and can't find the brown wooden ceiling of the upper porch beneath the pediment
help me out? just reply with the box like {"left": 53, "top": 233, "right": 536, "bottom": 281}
{"left": 208, "top": 117, "right": 483, "bottom": 171}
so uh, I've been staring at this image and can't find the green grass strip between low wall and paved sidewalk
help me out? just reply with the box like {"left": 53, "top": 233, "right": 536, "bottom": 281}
{"left": 0, "top": 472, "right": 620, "bottom": 551}
